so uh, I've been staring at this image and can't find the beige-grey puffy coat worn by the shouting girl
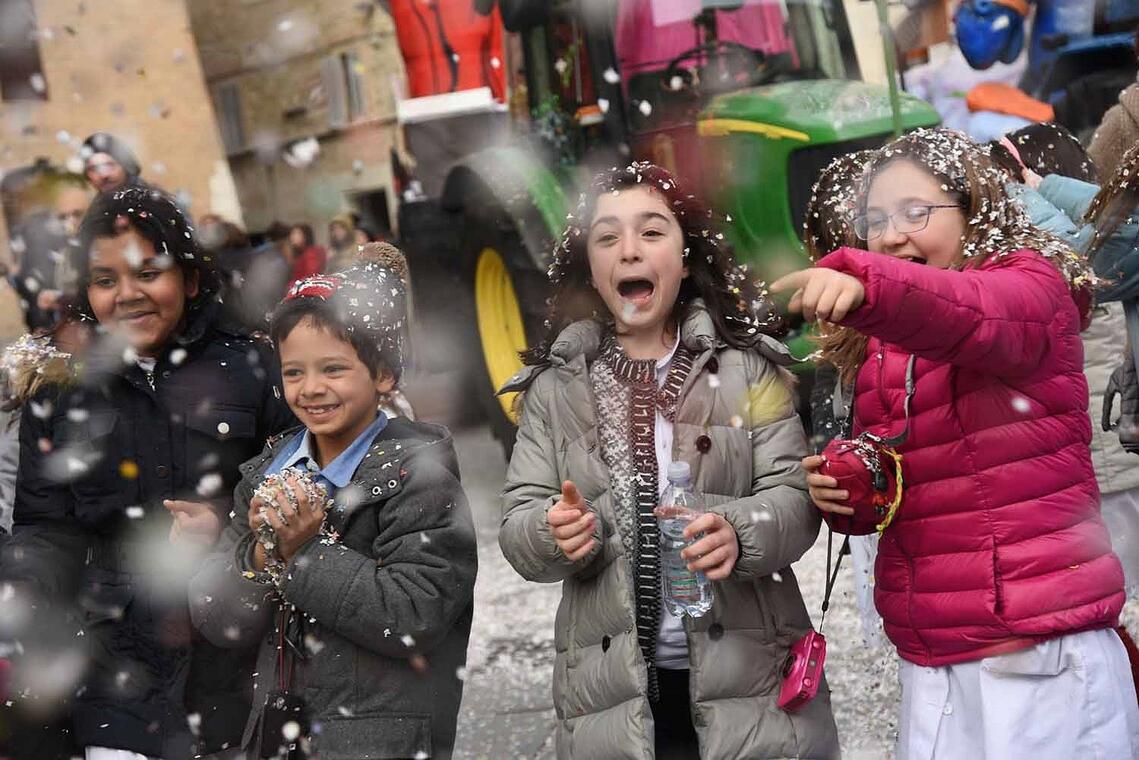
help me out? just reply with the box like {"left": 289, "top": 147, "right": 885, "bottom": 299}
{"left": 499, "top": 309, "right": 838, "bottom": 760}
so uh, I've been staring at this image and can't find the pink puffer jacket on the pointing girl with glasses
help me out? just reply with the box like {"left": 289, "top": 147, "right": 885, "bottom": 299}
{"left": 819, "top": 248, "right": 1124, "bottom": 665}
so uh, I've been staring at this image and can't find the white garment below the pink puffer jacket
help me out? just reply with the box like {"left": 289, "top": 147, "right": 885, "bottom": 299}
{"left": 895, "top": 629, "right": 1139, "bottom": 760}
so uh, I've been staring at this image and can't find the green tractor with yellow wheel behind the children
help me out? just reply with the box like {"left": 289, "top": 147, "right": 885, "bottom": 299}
{"left": 400, "top": 0, "right": 939, "bottom": 451}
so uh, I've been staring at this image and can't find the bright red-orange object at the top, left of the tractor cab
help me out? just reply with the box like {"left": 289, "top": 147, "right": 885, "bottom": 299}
{"left": 391, "top": 0, "right": 506, "bottom": 101}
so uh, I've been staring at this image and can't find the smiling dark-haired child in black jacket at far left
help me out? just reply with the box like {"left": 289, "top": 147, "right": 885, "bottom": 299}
{"left": 0, "top": 187, "right": 292, "bottom": 760}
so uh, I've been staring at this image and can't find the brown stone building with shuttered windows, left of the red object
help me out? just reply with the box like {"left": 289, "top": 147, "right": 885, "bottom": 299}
{"left": 190, "top": 0, "right": 403, "bottom": 239}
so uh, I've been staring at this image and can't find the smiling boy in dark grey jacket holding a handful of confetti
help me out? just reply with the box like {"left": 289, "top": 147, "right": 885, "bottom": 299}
{"left": 190, "top": 247, "right": 476, "bottom": 758}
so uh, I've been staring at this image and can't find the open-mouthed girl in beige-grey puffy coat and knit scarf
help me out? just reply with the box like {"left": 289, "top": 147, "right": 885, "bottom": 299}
{"left": 499, "top": 163, "right": 838, "bottom": 760}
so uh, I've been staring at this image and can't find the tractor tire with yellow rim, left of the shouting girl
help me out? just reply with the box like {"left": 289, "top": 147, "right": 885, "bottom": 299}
{"left": 461, "top": 212, "right": 549, "bottom": 461}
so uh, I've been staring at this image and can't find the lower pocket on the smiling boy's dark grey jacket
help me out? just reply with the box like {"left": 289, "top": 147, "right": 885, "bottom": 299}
{"left": 312, "top": 712, "right": 433, "bottom": 760}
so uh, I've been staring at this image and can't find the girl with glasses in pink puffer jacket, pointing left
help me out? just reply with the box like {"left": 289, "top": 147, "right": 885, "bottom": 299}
{"left": 772, "top": 130, "right": 1139, "bottom": 760}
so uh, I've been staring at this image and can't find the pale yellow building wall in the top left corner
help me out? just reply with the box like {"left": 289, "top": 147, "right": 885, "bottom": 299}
{"left": 0, "top": 0, "right": 240, "bottom": 258}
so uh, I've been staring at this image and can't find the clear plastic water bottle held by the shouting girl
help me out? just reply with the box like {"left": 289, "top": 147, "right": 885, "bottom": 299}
{"left": 656, "top": 461, "right": 712, "bottom": 618}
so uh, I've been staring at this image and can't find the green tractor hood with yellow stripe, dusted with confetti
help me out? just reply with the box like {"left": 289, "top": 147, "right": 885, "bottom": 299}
{"left": 699, "top": 80, "right": 940, "bottom": 144}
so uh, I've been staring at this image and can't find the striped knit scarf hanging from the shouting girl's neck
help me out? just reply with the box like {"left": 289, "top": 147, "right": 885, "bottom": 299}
{"left": 590, "top": 335, "right": 695, "bottom": 702}
